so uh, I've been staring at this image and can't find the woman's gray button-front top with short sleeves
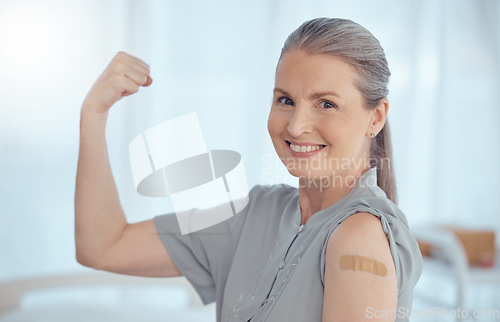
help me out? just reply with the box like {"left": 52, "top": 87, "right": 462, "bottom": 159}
{"left": 155, "top": 168, "right": 422, "bottom": 322}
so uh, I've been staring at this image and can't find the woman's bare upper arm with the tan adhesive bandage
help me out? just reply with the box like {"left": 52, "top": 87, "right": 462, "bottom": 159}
{"left": 323, "top": 213, "right": 398, "bottom": 322}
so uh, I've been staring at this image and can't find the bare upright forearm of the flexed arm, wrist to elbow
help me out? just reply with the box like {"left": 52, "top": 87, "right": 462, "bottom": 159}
{"left": 75, "top": 105, "right": 127, "bottom": 266}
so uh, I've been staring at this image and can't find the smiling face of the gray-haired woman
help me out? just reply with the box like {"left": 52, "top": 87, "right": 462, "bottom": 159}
{"left": 268, "top": 50, "right": 378, "bottom": 179}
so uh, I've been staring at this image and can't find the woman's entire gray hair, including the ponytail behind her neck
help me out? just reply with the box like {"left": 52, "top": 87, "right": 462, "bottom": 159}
{"left": 280, "top": 18, "right": 397, "bottom": 203}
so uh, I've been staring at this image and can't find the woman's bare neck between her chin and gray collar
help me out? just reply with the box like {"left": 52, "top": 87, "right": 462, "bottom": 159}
{"left": 299, "top": 167, "right": 369, "bottom": 225}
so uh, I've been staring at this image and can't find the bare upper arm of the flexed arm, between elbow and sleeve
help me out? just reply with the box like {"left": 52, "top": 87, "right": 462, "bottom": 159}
{"left": 93, "top": 219, "right": 182, "bottom": 277}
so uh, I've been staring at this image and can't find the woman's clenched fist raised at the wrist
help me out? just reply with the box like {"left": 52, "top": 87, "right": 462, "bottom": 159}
{"left": 83, "top": 52, "right": 153, "bottom": 113}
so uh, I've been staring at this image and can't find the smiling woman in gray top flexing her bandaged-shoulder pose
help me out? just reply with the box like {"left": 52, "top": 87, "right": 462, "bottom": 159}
{"left": 75, "top": 18, "right": 422, "bottom": 321}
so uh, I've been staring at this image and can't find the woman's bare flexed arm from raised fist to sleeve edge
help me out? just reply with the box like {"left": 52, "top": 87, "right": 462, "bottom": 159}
{"left": 75, "top": 52, "right": 180, "bottom": 276}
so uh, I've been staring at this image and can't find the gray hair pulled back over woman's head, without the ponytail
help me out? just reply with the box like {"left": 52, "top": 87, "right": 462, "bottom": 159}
{"left": 280, "top": 18, "right": 391, "bottom": 108}
